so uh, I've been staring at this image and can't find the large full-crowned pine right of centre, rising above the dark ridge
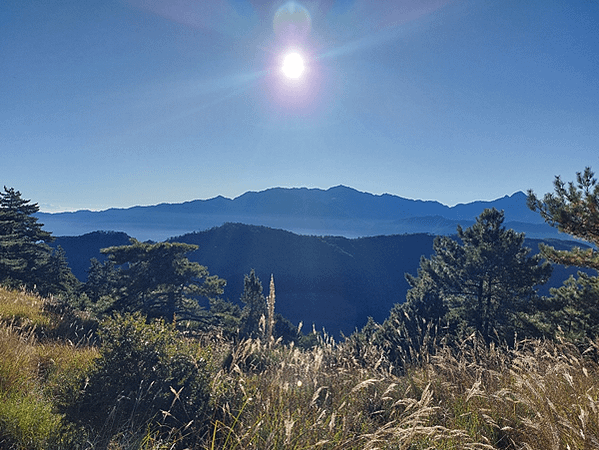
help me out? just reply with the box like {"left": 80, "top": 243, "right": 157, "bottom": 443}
{"left": 406, "top": 209, "right": 551, "bottom": 340}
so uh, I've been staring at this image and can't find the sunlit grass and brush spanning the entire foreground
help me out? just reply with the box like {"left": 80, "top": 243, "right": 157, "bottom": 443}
{"left": 0, "top": 289, "right": 599, "bottom": 449}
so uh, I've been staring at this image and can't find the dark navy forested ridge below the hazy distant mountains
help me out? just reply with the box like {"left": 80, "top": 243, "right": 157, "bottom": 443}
{"left": 53, "top": 223, "right": 592, "bottom": 334}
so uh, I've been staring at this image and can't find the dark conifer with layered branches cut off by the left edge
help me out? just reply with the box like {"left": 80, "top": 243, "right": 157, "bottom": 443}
{"left": 0, "top": 186, "right": 79, "bottom": 296}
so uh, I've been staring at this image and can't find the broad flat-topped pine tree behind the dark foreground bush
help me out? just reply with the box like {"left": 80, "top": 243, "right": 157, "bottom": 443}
{"left": 98, "top": 239, "right": 226, "bottom": 321}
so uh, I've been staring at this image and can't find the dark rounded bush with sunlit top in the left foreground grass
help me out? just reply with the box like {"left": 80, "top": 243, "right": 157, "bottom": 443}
{"left": 66, "top": 314, "right": 210, "bottom": 445}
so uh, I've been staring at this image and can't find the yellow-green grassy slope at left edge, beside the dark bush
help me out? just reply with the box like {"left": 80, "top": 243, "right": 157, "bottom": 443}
{"left": 0, "top": 289, "right": 97, "bottom": 450}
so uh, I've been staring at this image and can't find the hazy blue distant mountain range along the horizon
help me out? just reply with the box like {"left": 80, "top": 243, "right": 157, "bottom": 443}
{"left": 37, "top": 186, "right": 568, "bottom": 241}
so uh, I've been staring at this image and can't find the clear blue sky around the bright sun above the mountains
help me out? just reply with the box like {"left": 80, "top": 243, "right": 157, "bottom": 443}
{"left": 0, "top": 0, "right": 599, "bottom": 212}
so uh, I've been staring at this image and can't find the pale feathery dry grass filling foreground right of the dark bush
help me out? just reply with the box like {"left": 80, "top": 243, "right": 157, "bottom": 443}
{"left": 203, "top": 330, "right": 599, "bottom": 450}
